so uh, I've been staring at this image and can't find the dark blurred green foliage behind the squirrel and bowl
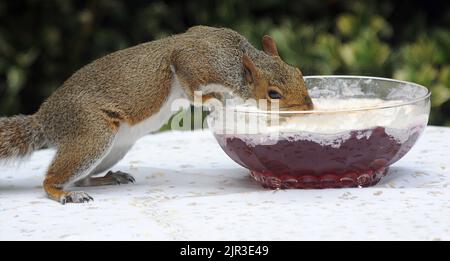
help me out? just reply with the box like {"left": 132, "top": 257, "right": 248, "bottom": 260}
{"left": 0, "top": 0, "right": 450, "bottom": 125}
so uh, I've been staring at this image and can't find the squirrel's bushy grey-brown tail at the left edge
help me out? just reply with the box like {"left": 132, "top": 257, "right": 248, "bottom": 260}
{"left": 0, "top": 115, "right": 46, "bottom": 162}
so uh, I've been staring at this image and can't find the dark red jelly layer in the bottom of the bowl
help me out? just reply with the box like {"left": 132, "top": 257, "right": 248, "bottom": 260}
{"left": 215, "top": 126, "right": 425, "bottom": 189}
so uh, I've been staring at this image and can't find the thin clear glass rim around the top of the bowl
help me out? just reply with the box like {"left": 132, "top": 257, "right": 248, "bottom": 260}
{"left": 227, "top": 75, "right": 431, "bottom": 115}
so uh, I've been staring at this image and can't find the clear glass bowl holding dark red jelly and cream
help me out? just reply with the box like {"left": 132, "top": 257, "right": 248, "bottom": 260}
{"left": 208, "top": 76, "right": 430, "bottom": 189}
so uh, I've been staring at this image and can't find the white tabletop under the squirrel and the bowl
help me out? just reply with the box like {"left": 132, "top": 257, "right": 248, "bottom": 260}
{"left": 0, "top": 127, "right": 450, "bottom": 240}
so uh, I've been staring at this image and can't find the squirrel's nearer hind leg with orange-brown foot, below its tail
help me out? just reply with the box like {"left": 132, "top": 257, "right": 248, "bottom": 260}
{"left": 44, "top": 128, "right": 115, "bottom": 204}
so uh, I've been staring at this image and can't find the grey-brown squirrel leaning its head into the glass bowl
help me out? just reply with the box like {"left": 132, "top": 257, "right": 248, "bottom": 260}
{"left": 0, "top": 26, "right": 313, "bottom": 204}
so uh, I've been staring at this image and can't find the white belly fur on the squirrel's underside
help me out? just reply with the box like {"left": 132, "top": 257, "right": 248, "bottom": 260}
{"left": 92, "top": 74, "right": 187, "bottom": 174}
